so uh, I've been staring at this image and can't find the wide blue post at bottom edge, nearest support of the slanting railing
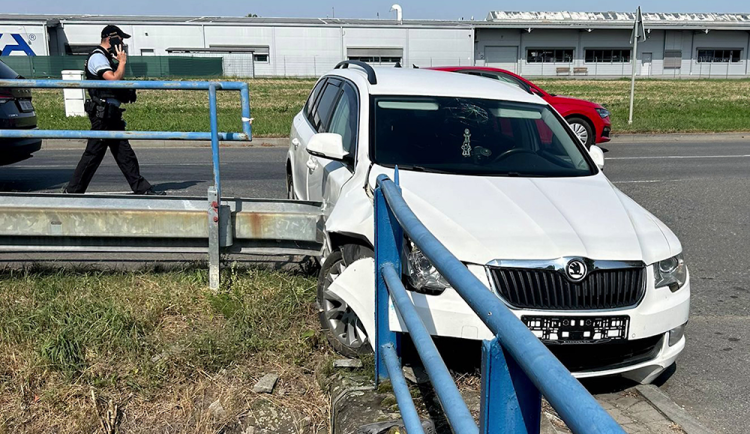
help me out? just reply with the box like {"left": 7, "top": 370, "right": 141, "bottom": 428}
{"left": 479, "top": 338, "right": 542, "bottom": 434}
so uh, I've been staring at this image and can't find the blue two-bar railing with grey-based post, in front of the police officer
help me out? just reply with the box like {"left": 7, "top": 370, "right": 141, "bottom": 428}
{"left": 0, "top": 79, "right": 252, "bottom": 289}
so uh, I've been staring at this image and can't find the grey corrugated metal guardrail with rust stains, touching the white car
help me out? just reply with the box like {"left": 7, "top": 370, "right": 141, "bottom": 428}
{"left": 0, "top": 193, "right": 322, "bottom": 255}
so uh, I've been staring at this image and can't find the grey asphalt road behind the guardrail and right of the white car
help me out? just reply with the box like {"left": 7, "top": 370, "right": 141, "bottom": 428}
{"left": 0, "top": 138, "right": 750, "bottom": 434}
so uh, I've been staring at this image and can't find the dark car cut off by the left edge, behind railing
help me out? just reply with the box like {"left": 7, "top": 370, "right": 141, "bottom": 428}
{"left": 0, "top": 61, "right": 42, "bottom": 165}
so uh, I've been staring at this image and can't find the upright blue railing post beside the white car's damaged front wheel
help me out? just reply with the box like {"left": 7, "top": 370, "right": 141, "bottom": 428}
{"left": 374, "top": 173, "right": 404, "bottom": 383}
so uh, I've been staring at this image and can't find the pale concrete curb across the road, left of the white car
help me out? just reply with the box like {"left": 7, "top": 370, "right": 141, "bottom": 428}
{"left": 42, "top": 137, "right": 289, "bottom": 151}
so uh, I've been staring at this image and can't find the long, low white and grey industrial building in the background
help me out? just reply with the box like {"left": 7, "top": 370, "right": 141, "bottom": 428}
{"left": 0, "top": 11, "right": 750, "bottom": 78}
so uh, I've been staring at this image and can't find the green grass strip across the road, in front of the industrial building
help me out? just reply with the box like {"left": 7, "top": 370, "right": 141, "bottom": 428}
{"left": 29, "top": 78, "right": 750, "bottom": 137}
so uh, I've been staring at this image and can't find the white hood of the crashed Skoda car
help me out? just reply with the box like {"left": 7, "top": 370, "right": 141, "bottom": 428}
{"left": 389, "top": 171, "right": 682, "bottom": 264}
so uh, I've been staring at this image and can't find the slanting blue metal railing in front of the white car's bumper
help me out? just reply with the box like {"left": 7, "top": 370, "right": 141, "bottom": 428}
{"left": 374, "top": 170, "right": 624, "bottom": 434}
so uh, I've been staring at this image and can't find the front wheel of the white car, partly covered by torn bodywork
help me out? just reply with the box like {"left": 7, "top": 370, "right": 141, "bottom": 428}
{"left": 318, "top": 244, "right": 375, "bottom": 357}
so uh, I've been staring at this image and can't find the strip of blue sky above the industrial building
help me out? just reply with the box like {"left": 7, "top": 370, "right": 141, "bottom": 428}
{"left": 5, "top": 0, "right": 750, "bottom": 20}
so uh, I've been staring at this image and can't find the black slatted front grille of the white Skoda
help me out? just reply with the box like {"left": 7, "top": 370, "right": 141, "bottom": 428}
{"left": 490, "top": 267, "right": 646, "bottom": 310}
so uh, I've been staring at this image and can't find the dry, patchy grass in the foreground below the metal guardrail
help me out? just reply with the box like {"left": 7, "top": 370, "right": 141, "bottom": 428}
{"left": 0, "top": 270, "right": 332, "bottom": 433}
